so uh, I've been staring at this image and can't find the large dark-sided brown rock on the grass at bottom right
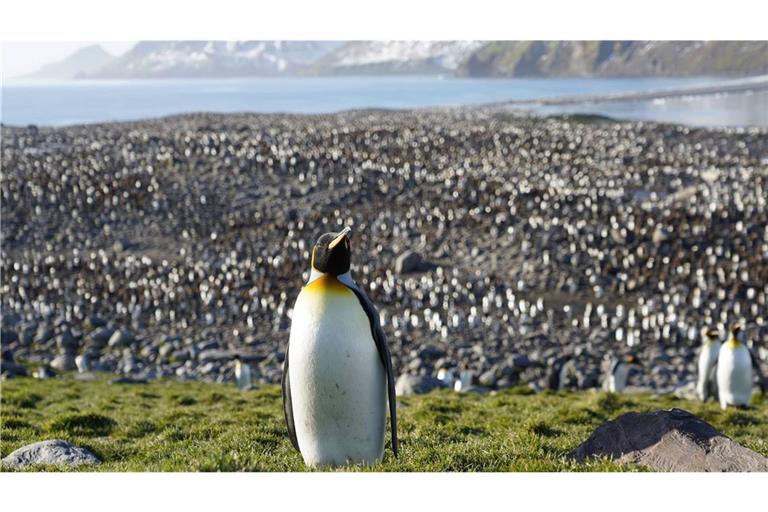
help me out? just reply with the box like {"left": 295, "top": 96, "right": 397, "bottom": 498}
{"left": 570, "top": 409, "right": 768, "bottom": 471}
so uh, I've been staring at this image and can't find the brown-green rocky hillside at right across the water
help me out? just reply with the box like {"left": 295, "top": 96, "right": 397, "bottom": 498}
{"left": 457, "top": 41, "right": 768, "bottom": 77}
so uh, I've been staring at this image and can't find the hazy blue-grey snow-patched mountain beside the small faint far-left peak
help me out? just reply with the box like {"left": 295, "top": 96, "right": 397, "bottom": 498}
{"left": 87, "top": 41, "right": 341, "bottom": 78}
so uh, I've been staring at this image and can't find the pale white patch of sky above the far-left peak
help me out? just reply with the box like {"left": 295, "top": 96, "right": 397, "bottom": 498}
{"left": 2, "top": 41, "right": 136, "bottom": 78}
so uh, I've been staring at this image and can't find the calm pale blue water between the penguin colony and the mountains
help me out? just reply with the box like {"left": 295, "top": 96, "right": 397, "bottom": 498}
{"left": 6, "top": 76, "right": 768, "bottom": 127}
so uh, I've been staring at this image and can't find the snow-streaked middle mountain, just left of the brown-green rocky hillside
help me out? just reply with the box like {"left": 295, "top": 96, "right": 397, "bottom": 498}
{"left": 313, "top": 41, "right": 483, "bottom": 74}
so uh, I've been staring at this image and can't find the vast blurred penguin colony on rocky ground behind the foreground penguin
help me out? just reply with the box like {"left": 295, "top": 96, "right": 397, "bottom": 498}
{"left": 0, "top": 109, "right": 768, "bottom": 394}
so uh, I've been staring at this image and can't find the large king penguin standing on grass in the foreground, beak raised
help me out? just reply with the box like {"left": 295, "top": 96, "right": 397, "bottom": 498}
{"left": 282, "top": 227, "right": 398, "bottom": 466}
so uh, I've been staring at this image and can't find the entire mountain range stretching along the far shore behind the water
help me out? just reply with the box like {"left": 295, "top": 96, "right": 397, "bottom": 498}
{"left": 28, "top": 41, "right": 768, "bottom": 79}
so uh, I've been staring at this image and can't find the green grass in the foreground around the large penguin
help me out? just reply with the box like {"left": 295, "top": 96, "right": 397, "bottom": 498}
{"left": 0, "top": 376, "right": 768, "bottom": 471}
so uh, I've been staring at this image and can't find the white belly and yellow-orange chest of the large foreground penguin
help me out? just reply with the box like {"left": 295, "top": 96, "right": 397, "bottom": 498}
{"left": 288, "top": 277, "right": 387, "bottom": 466}
